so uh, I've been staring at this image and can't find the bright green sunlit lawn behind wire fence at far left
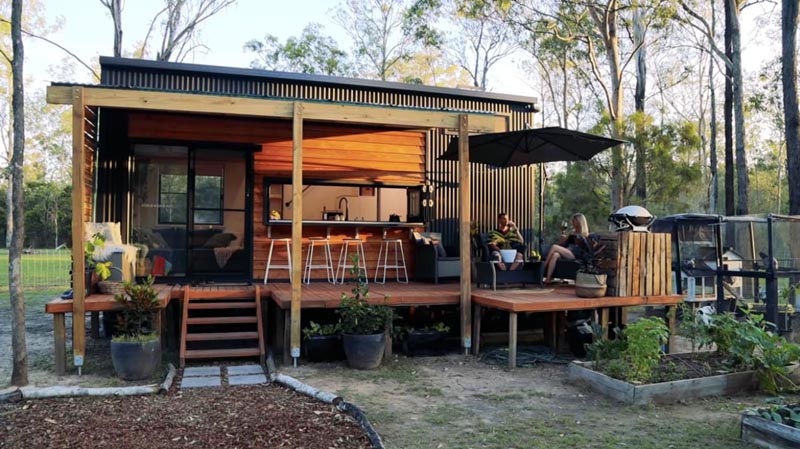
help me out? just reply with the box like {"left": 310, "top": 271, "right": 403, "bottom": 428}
{"left": 0, "top": 249, "right": 72, "bottom": 294}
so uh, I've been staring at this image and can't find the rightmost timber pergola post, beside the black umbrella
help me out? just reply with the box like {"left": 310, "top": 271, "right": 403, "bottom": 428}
{"left": 458, "top": 114, "right": 472, "bottom": 354}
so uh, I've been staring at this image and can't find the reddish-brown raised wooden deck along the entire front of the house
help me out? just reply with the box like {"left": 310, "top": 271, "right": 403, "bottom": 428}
{"left": 45, "top": 282, "right": 682, "bottom": 374}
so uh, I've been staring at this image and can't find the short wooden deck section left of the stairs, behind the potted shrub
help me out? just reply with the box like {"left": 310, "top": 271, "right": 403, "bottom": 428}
{"left": 44, "top": 285, "right": 173, "bottom": 376}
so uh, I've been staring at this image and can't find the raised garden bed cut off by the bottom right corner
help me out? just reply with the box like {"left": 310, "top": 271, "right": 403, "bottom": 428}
{"left": 742, "top": 405, "right": 800, "bottom": 449}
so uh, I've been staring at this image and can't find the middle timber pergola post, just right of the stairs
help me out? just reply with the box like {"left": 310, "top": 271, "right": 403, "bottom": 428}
{"left": 291, "top": 102, "right": 303, "bottom": 366}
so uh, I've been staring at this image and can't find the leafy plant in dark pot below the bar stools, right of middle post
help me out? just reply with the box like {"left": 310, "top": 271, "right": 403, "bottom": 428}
{"left": 337, "top": 257, "right": 392, "bottom": 369}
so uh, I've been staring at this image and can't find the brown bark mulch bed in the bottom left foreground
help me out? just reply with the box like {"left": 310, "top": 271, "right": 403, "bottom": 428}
{"left": 0, "top": 385, "right": 371, "bottom": 449}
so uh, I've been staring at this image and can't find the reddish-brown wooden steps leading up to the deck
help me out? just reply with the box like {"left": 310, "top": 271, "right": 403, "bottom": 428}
{"left": 180, "top": 285, "right": 265, "bottom": 368}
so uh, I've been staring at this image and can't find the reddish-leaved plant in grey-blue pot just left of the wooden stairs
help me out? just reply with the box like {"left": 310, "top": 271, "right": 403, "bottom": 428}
{"left": 111, "top": 276, "right": 161, "bottom": 380}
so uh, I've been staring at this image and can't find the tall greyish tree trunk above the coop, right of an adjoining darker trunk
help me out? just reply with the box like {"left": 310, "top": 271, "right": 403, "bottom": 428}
{"left": 728, "top": 0, "right": 749, "bottom": 215}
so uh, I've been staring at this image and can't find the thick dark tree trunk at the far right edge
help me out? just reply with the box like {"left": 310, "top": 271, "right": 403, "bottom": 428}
{"left": 781, "top": 0, "right": 800, "bottom": 215}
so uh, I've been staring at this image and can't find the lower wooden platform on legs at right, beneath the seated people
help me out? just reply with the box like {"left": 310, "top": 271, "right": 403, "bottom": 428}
{"left": 472, "top": 286, "right": 683, "bottom": 368}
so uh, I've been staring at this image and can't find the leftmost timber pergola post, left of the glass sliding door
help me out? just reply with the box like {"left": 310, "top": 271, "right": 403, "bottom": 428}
{"left": 72, "top": 87, "right": 86, "bottom": 374}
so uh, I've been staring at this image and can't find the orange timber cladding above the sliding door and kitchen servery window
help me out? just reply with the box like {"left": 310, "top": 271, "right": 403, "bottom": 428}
{"left": 129, "top": 113, "right": 426, "bottom": 186}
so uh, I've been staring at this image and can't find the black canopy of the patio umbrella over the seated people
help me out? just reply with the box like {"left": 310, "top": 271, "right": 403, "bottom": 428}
{"left": 439, "top": 127, "right": 627, "bottom": 167}
